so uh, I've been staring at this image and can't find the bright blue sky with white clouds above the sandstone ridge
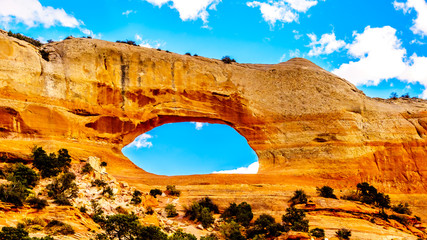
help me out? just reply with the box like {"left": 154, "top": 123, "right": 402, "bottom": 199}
{"left": 0, "top": 0, "right": 427, "bottom": 174}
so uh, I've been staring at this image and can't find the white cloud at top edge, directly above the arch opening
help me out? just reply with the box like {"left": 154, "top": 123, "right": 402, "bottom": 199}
{"left": 146, "top": 0, "right": 221, "bottom": 24}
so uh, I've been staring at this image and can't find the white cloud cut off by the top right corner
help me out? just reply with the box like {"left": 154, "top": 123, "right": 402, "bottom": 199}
{"left": 393, "top": 0, "right": 427, "bottom": 36}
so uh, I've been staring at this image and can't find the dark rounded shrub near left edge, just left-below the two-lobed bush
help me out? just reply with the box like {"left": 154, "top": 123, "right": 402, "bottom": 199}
{"left": 7, "top": 163, "right": 39, "bottom": 188}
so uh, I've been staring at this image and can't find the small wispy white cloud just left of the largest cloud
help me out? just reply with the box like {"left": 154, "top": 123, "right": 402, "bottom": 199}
{"left": 307, "top": 33, "right": 346, "bottom": 56}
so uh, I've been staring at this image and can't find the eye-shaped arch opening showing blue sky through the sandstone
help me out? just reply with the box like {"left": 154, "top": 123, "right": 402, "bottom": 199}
{"left": 122, "top": 122, "right": 259, "bottom": 176}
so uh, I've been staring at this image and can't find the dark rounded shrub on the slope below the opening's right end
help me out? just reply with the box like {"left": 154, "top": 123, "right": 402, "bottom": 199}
{"left": 221, "top": 202, "right": 254, "bottom": 226}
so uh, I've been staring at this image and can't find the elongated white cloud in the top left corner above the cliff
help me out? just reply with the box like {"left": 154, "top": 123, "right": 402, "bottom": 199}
{"left": 0, "top": 0, "right": 82, "bottom": 28}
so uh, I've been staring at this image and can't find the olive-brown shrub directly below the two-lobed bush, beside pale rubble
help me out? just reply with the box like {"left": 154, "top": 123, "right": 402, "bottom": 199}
{"left": 46, "top": 173, "right": 78, "bottom": 205}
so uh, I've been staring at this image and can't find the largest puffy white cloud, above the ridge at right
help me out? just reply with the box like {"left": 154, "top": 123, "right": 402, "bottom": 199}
{"left": 332, "top": 26, "right": 427, "bottom": 97}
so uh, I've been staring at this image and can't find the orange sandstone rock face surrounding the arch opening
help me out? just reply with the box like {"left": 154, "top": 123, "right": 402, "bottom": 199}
{"left": 0, "top": 32, "right": 427, "bottom": 192}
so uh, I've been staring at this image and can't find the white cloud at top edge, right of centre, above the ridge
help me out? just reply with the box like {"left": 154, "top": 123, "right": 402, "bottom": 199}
{"left": 246, "top": 0, "right": 318, "bottom": 27}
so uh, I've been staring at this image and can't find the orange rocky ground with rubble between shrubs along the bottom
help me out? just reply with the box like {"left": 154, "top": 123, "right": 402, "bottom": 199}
{"left": 0, "top": 157, "right": 427, "bottom": 240}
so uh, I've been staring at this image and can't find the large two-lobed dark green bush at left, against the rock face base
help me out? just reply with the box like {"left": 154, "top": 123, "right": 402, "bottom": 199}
{"left": 32, "top": 147, "right": 71, "bottom": 178}
